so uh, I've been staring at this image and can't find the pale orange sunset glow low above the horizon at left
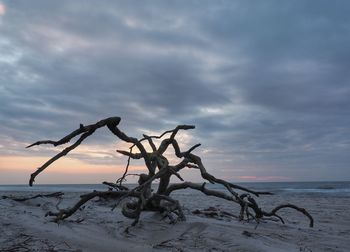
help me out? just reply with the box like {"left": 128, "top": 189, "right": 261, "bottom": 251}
{"left": 0, "top": 156, "right": 145, "bottom": 184}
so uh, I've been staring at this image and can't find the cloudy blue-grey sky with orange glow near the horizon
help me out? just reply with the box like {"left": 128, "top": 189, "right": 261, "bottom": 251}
{"left": 0, "top": 0, "right": 350, "bottom": 184}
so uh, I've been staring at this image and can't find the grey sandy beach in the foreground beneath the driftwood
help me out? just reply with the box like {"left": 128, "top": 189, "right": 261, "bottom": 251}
{"left": 0, "top": 187, "right": 350, "bottom": 251}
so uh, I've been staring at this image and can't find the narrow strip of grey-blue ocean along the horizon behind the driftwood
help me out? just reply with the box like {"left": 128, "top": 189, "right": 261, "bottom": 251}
{"left": 0, "top": 181, "right": 350, "bottom": 197}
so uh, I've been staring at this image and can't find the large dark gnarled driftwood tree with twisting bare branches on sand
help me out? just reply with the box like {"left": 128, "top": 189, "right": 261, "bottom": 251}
{"left": 27, "top": 117, "right": 313, "bottom": 227}
